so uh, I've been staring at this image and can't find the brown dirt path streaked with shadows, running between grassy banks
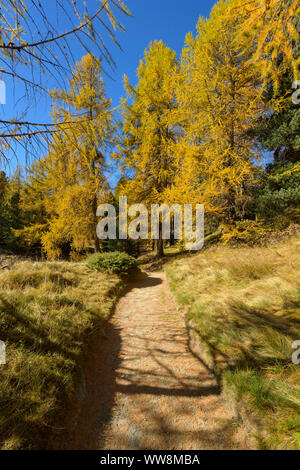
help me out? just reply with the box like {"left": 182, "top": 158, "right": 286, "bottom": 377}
{"left": 64, "top": 273, "right": 240, "bottom": 450}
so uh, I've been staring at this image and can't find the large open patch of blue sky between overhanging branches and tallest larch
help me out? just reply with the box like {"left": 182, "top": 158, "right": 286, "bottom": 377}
{"left": 107, "top": 0, "right": 216, "bottom": 105}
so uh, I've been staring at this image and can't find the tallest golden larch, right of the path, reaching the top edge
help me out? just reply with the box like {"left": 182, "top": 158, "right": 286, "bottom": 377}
{"left": 172, "top": 1, "right": 272, "bottom": 223}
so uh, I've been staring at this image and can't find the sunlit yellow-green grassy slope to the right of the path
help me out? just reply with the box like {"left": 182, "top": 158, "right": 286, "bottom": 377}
{"left": 166, "top": 238, "right": 300, "bottom": 449}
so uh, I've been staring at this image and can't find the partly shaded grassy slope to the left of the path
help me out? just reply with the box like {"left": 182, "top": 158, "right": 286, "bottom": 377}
{"left": 0, "top": 262, "right": 121, "bottom": 449}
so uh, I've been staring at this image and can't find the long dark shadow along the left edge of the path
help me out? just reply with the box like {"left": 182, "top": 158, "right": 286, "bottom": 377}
{"left": 57, "top": 322, "right": 121, "bottom": 450}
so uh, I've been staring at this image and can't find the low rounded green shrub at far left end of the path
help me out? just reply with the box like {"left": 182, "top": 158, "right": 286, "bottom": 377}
{"left": 87, "top": 251, "right": 137, "bottom": 274}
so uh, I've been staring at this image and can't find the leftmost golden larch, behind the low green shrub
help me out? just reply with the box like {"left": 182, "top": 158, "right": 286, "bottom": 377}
{"left": 18, "top": 54, "right": 114, "bottom": 259}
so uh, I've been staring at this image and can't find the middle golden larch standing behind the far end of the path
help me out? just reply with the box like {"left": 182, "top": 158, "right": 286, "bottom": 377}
{"left": 116, "top": 41, "right": 177, "bottom": 257}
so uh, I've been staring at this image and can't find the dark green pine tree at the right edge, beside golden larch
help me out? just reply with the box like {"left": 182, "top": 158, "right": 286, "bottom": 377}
{"left": 250, "top": 18, "right": 300, "bottom": 223}
